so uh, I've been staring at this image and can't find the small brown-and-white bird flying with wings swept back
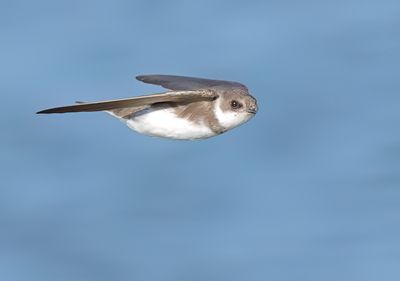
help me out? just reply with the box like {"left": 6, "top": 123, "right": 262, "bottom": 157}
{"left": 37, "top": 74, "right": 258, "bottom": 140}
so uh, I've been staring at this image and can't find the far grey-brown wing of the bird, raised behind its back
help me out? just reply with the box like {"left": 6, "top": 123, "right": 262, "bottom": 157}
{"left": 136, "top": 75, "right": 247, "bottom": 91}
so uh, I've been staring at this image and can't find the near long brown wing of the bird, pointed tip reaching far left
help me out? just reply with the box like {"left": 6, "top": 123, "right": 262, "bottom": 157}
{"left": 37, "top": 90, "right": 217, "bottom": 114}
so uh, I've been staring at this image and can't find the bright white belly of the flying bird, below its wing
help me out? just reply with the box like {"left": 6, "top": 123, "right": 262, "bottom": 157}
{"left": 126, "top": 108, "right": 215, "bottom": 140}
